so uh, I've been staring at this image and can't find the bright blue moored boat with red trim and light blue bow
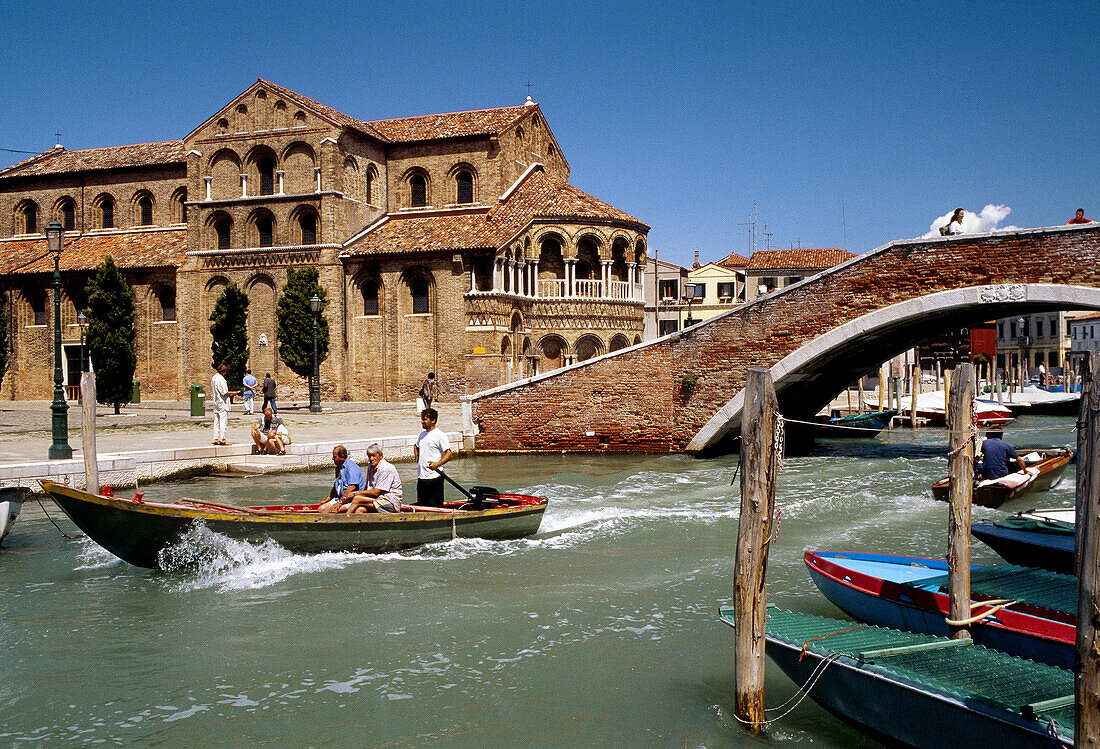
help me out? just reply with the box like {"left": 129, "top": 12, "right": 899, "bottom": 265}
{"left": 803, "top": 551, "right": 1077, "bottom": 669}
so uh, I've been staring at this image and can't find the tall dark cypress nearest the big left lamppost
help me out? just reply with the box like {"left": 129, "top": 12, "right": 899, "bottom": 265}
{"left": 87, "top": 255, "right": 138, "bottom": 414}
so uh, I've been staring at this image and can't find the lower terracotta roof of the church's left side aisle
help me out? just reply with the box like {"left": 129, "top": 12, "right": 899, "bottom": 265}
{"left": 0, "top": 228, "right": 187, "bottom": 273}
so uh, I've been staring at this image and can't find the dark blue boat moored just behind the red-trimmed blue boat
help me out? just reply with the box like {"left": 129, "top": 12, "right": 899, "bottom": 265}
{"left": 970, "top": 508, "right": 1077, "bottom": 575}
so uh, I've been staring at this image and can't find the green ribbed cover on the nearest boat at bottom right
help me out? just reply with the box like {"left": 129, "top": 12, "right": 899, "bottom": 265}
{"left": 739, "top": 608, "right": 1075, "bottom": 736}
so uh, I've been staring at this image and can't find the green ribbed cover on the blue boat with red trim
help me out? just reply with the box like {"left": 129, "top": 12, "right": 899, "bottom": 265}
{"left": 919, "top": 564, "right": 1077, "bottom": 616}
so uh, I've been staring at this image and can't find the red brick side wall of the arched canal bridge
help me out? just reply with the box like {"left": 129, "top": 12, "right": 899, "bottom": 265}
{"left": 473, "top": 224, "right": 1100, "bottom": 452}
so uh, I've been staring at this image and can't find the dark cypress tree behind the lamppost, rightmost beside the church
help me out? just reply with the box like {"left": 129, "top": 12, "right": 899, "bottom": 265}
{"left": 276, "top": 265, "right": 329, "bottom": 379}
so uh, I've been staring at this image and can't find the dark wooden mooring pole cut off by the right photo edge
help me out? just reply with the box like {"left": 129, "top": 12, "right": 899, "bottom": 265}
{"left": 1075, "top": 351, "right": 1100, "bottom": 747}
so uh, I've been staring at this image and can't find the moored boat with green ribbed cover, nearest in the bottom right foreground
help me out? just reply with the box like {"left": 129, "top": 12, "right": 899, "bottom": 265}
{"left": 719, "top": 608, "right": 1075, "bottom": 749}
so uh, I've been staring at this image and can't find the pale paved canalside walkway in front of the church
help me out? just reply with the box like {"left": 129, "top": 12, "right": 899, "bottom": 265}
{"left": 0, "top": 400, "right": 462, "bottom": 488}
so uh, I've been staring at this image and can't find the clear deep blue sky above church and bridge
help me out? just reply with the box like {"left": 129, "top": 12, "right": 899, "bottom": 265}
{"left": 0, "top": 0, "right": 1100, "bottom": 264}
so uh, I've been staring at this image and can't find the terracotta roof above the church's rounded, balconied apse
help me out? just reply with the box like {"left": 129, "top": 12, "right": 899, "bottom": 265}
{"left": 345, "top": 169, "right": 649, "bottom": 256}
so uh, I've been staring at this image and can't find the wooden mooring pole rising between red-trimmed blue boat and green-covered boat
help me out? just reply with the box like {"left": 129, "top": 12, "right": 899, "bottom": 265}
{"left": 947, "top": 364, "right": 975, "bottom": 640}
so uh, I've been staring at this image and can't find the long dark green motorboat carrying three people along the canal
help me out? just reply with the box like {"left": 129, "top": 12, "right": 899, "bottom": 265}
{"left": 41, "top": 481, "right": 547, "bottom": 568}
